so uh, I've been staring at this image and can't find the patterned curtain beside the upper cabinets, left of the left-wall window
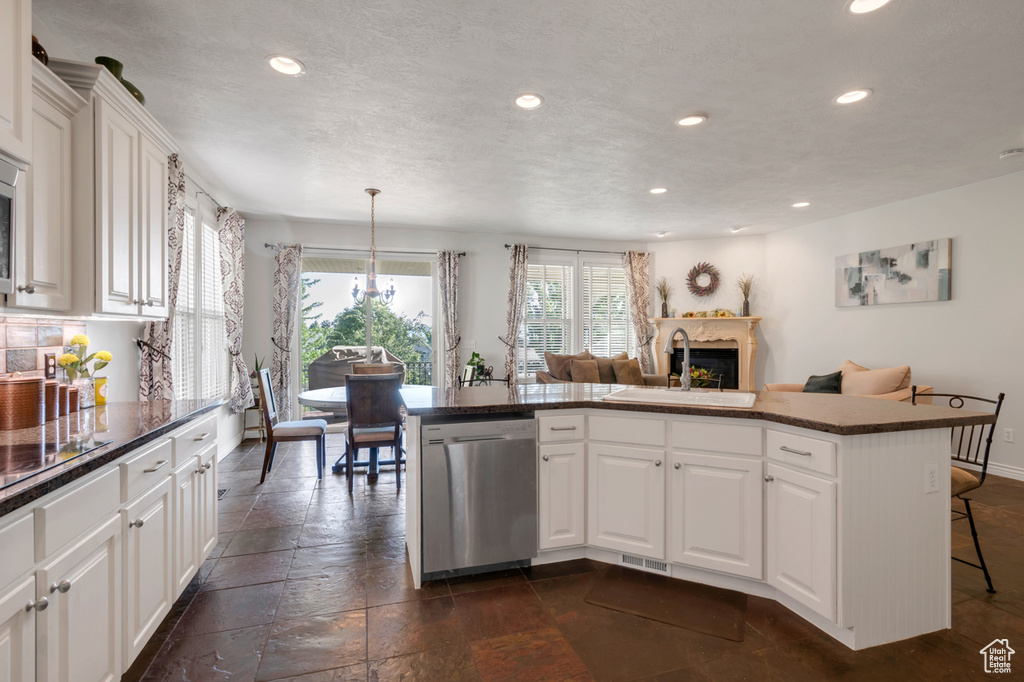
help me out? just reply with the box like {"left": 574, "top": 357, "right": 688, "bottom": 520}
{"left": 138, "top": 154, "right": 185, "bottom": 400}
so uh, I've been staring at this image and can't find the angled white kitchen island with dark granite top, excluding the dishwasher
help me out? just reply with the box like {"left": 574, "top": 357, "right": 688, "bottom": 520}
{"left": 407, "top": 384, "right": 993, "bottom": 649}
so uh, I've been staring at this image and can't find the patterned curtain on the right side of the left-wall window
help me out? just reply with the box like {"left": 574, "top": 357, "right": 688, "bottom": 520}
{"left": 217, "top": 207, "right": 254, "bottom": 413}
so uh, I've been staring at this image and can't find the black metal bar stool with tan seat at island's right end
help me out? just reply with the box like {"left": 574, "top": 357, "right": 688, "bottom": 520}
{"left": 910, "top": 386, "right": 1006, "bottom": 594}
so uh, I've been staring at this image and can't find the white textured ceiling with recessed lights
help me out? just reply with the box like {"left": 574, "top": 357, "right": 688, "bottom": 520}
{"left": 28, "top": 0, "right": 1024, "bottom": 240}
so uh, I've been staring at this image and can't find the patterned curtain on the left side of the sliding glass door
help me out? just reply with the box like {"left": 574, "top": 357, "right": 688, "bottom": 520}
{"left": 270, "top": 244, "right": 302, "bottom": 422}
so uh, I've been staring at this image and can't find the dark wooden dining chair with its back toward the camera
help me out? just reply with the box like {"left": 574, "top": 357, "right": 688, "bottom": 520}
{"left": 345, "top": 374, "right": 402, "bottom": 493}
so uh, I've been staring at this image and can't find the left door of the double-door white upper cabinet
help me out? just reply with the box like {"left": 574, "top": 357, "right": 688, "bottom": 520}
{"left": 95, "top": 97, "right": 140, "bottom": 315}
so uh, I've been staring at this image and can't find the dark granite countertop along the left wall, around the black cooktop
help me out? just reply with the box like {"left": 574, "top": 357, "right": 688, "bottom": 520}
{"left": 0, "top": 400, "right": 223, "bottom": 516}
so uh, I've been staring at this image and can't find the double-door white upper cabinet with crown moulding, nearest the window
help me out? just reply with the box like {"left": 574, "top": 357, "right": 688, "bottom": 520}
{"left": 50, "top": 59, "right": 175, "bottom": 318}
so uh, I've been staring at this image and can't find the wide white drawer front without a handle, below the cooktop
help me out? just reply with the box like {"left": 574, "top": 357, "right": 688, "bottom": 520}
{"left": 36, "top": 468, "right": 121, "bottom": 561}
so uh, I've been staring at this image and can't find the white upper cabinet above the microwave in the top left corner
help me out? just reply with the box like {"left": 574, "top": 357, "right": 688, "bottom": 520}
{"left": 0, "top": 0, "right": 34, "bottom": 163}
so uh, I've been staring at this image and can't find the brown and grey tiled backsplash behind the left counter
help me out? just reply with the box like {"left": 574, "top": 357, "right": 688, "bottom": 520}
{"left": 0, "top": 317, "right": 85, "bottom": 376}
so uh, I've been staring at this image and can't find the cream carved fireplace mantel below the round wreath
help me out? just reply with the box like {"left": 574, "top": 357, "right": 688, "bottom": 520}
{"left": 650, "top": 317, "right": 761, "bottom": 391}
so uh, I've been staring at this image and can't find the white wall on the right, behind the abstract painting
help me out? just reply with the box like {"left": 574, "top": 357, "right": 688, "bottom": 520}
{"left": 770, "top": 166, "right": 1024, "bottom": 473}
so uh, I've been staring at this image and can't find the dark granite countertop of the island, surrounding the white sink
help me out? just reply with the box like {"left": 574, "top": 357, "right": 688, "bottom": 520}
{"left": 402, "top": 384, "right": 995, "bottom": 435}
